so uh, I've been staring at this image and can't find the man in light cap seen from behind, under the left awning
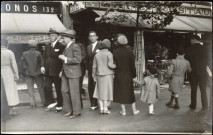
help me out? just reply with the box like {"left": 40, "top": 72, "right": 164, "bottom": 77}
{"left": 21, "top": 40, "right": 45, "bottom": 108}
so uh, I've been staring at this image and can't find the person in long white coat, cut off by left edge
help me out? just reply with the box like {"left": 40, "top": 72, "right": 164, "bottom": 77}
{"left": 1, "top": 39, "right": 19, "bottom": 115}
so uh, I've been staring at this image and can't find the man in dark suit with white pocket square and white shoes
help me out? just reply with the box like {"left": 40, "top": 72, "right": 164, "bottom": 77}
{"left": 41, "top": 29, "right": 64, "bottom": 111}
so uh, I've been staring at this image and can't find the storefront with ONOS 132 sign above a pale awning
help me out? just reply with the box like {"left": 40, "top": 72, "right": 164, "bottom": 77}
{"left": 1, "top": 1, "right": 66, "bottom": 78}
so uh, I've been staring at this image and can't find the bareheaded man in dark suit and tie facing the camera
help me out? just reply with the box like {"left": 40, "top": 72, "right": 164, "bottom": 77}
{"left": 87, "top": 31, "right": 100, "bottom": 110}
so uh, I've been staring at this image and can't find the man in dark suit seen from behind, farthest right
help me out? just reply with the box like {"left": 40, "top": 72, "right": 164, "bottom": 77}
{"left": 186, "top": 35, "right": 211, "bottom": 110}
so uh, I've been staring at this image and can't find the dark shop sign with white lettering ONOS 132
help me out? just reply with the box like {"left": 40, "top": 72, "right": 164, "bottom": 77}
{"left": 1, "top": 1, "right": 61, "bottom": 14}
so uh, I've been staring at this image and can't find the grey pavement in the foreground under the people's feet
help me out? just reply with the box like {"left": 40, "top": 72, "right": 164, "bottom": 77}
{"left": 1, "top": 79, "right": 212, "bottom": 134}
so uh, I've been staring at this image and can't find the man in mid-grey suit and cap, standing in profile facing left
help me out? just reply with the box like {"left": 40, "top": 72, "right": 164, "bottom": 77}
{"left": 59, "top": 30, "right": 82, "bottom": 119}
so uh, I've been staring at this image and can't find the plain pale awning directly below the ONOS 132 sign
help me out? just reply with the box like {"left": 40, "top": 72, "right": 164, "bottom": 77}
{"left": 1, "top": 13, "right": 66, "bottom": 33}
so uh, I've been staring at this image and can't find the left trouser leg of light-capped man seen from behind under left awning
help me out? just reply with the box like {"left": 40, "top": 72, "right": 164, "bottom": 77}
{"left": 25, "top": 77, "right": 36, "bottom": 105}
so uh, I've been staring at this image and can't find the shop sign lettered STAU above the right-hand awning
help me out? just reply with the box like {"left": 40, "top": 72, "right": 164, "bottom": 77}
{"left": 179, "top": 7, "right": 212, "bottom": 17}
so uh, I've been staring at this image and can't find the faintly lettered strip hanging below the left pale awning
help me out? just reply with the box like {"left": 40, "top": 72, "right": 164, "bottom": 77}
{"left": 7, "top": 34, "right": 49, "bottom": 44}
